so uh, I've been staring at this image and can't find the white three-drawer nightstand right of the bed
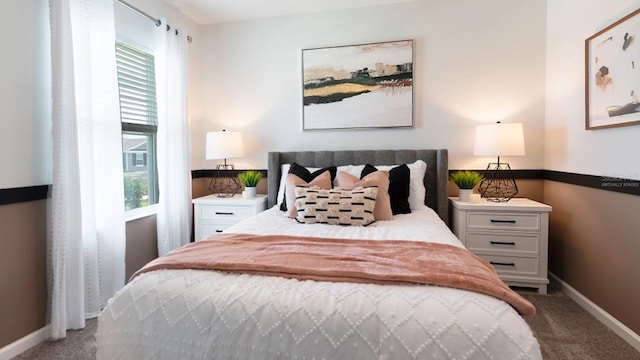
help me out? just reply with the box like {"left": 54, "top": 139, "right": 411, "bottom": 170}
{"left": 449, "top": 198, "right": 551, "bottom": 294}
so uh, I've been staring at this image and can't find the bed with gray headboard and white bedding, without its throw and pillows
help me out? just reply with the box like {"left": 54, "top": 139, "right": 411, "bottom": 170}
{"left": 96, "top": 150, "right": 541, "bottom": 359}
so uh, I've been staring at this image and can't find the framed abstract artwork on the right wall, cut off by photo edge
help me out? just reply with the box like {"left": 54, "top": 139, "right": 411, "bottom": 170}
{"left": 585, "top": 9, "right": 640, "bottom": 130}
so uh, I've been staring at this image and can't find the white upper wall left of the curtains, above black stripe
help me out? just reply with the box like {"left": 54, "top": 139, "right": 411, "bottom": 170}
{"left": 0, "top": 0, "right": 51, "bottom": 189}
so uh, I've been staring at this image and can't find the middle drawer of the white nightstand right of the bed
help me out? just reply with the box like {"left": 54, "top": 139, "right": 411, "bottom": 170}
{"left": 467, "top": 232, "right": 540, "bottom": 256}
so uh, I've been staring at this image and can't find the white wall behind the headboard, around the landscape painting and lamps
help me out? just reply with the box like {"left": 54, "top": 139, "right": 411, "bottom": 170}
{"left": 192, "top": 0, "right": 546, "bottom": 169}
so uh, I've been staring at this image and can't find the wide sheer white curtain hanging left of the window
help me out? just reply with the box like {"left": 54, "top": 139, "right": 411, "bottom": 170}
{"left": 48, "top": 0, "right": 125, "bottom": 339}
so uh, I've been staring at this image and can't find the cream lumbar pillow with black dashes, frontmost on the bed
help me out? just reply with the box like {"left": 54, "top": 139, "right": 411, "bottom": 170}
{"left": 295, "top": 186, "right": 378, "bottom": 226}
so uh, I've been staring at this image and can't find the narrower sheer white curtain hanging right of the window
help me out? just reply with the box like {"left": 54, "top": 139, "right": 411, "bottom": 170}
{"left": 155, "top": 19, "right": 191, "bottom": 255}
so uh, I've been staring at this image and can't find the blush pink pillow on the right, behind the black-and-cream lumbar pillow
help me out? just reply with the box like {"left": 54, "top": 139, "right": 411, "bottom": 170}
{"left": 336, "top": 171, "right": 393, "bottom": 220}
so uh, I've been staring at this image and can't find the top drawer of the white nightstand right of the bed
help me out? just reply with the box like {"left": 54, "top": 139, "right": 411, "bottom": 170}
{"left": 467, "top": 211, "right": 540, "bottom": 231}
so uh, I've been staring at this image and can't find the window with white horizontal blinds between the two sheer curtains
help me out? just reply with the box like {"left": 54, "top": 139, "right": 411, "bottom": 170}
{"left": 116, "top": 42, "right": 158, "bottom": 210}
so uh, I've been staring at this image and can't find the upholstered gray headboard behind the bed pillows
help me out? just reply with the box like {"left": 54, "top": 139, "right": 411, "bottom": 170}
{"left": 267, "top": 149, "right": 449, "bottom": 223}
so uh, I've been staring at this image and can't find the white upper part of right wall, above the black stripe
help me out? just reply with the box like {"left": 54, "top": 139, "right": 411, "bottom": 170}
{"left": 544, "top": 0, "right": 640, "bottom": 179}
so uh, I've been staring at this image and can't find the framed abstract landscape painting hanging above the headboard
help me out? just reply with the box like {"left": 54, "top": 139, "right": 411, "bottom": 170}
{"left": 301, "top": 39, "right": 415, "bottom": 131}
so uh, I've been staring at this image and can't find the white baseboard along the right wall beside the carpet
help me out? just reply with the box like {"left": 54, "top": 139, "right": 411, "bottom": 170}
{"left": 549, "top": 272, "right": 640, "bottom": 351}
